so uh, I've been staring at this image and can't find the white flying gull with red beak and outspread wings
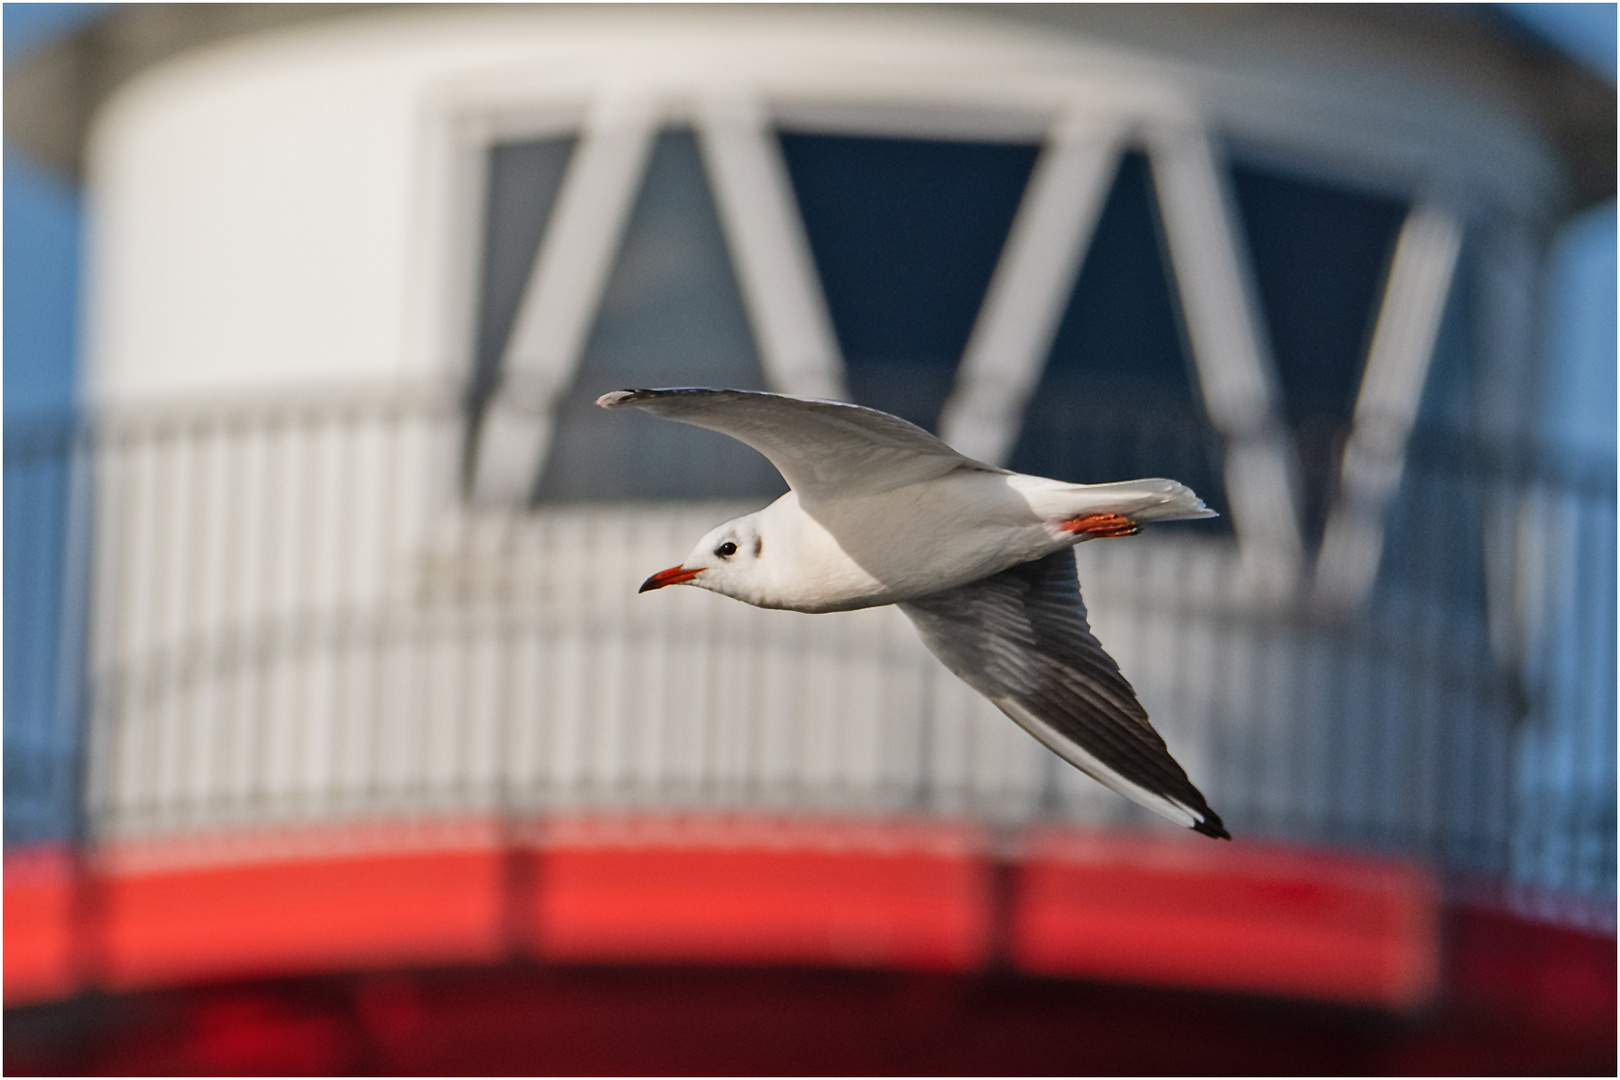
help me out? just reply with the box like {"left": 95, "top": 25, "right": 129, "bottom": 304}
{"left": 596, "top": 387, "right": 1231, "bottom": 840}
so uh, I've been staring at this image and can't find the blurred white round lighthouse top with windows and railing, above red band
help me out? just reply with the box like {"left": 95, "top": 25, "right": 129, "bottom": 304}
{"left": 6, "top": 5, "right": 1615, "bottom": 1055}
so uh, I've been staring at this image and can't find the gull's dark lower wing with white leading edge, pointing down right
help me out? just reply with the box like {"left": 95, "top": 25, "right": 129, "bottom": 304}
{"left": 899, "top": 549, "right": 1231, "bottom": 839}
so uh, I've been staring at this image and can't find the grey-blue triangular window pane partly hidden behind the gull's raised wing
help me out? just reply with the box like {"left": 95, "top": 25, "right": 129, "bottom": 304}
{"left": 536, "top": 130, "right": 787, "bottom": 502}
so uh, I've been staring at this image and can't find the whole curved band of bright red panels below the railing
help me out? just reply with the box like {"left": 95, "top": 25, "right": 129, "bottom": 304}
{"left": 5, "top": 818, "right": 1594, "bottom": 1010}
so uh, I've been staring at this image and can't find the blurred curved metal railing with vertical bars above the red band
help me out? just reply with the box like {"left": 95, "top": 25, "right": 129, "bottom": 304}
{"left": 5, "top": 383, "right": 1615, "bottom": 926}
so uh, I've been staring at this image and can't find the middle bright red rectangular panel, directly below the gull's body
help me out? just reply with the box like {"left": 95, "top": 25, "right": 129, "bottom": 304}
{"left": 531, "top": 818, "right": 991, "bottom": 972}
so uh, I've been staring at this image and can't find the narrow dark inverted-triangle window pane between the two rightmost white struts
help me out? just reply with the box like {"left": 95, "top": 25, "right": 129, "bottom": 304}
{"left": 1233, "top": 165, "right": 1406, "bottom": 546}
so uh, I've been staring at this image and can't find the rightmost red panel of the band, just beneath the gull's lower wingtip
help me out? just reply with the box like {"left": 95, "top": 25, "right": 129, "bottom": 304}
{"left": 1011, "top": 829, "right": 1440, "bottom": 1009}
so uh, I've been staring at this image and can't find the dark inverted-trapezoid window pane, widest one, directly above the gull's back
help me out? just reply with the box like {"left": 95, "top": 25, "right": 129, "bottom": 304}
{"left": 781, "top": 133, "right": 1038, "bottom": 431}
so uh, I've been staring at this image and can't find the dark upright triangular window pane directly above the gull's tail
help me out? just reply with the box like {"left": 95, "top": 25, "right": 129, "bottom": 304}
{"left": 1011, "top": 152, "right": 1231, "bottom": 531}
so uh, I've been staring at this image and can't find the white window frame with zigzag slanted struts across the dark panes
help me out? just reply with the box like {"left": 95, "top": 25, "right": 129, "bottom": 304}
{"left": 414, "top": 71, "right": 1456, "bottom": 607}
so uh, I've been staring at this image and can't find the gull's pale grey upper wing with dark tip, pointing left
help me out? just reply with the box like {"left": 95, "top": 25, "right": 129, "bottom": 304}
{"left": 596, "top": 389, "right": 1004, "bottom": 500}
